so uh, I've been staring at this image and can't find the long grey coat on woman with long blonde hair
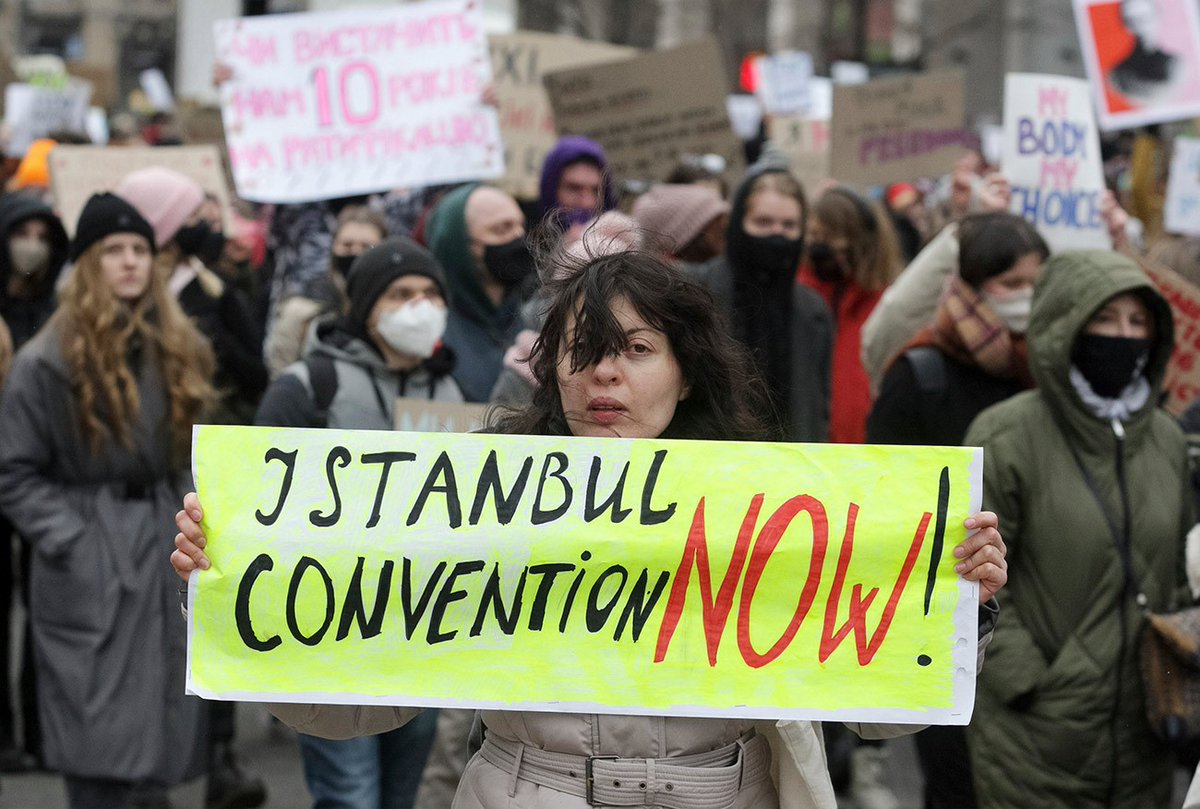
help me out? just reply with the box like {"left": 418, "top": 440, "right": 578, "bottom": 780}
{"left": 0, "top": 319, "right": 204, "bottom": 784}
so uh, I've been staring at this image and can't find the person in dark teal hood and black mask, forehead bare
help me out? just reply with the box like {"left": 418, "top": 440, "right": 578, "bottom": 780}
{"left": 425, "top": 184, "right": 538, "bottom": 402}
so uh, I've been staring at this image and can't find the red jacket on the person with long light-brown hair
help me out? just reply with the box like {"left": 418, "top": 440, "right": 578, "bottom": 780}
{"left": 798, "top": 264, "right": 883, "bottom": 444}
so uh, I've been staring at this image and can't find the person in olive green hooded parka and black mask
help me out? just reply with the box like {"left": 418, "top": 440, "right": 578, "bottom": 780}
{"left": 966, "top": 251, "right": 1193, "bottom": 809}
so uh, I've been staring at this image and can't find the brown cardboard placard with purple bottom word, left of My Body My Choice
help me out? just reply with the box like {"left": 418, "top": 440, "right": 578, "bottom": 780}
{"left": 832, "top": 71, "right": 979, "bottom": 187}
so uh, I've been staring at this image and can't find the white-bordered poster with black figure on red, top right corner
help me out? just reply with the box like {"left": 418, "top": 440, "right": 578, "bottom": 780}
{"left": 1074, "top": 0, "right": 1200, "bottom": 130}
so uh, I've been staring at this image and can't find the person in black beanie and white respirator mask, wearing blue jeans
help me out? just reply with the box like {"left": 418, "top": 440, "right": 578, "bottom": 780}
{"left": 254, "top": 238, "right": 453, "bottom": 809}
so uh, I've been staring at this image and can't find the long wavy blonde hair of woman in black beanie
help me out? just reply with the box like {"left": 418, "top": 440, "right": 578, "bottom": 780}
{"left": 55, "top": 240, "right": 216, "bottom": 462}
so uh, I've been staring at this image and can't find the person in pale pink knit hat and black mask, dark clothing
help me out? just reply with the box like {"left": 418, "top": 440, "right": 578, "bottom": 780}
{"left": 116, "top": 166, "right": 268, "bottom": 424}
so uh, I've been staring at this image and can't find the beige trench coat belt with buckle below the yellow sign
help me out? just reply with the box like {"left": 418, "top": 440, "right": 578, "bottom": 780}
{"left": 479, "top": 732, "right": 770, "bottom": 809}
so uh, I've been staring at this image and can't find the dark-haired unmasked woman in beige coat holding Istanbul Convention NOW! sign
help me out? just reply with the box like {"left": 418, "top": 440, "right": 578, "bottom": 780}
{"left": 172, "top": 252, "right": 1007, "bottom": 809}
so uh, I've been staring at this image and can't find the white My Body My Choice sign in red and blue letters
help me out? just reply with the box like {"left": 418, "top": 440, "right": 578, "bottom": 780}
{"left": 1003, "top": 73, "right": 1112, "bottom": 251}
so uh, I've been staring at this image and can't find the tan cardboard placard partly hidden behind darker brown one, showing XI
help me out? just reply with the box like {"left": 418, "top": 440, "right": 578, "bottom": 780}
{"left": 487, "top": 31, "right": 637, "bottom": 199}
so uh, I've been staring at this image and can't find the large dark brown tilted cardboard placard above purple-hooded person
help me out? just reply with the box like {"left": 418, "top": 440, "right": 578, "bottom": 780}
{"left": 545, "top": 40, "right": 744, "bottom": 182}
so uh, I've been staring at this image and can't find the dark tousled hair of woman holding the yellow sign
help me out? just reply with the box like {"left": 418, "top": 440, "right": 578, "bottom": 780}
{"left": 490, "top": 251, "right": 780, "bottom": 441}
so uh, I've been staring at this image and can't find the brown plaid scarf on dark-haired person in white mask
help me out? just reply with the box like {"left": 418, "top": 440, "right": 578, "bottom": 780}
{"left": 906, "top": 275, "right": 1034, "bottom": 388}
